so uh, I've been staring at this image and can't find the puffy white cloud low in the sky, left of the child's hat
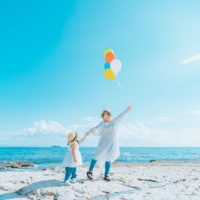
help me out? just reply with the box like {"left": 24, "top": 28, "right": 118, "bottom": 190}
{"left": 22, "top": 120, "right": 70, "bottom": 134}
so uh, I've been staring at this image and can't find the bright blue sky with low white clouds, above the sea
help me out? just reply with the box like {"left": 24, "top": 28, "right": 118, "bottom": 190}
{"left": 0, "top": 0, "right": 200, "bottom": 147}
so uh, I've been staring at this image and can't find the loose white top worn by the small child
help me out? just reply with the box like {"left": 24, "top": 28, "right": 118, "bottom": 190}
{"left": 63, "top": 141, "right": 83, "bottom": 167}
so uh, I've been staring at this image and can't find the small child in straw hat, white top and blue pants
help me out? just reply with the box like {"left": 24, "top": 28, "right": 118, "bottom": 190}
{"left": 63, "top": 132, "right": 87, "bottom": 185}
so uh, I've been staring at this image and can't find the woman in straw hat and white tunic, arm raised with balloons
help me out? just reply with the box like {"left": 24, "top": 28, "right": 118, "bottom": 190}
{"left": 86, "top": 106, "right": 132, "bottom": 181}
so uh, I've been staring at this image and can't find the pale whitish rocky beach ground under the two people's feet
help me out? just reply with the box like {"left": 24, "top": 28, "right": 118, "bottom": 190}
{"left": 0, "top": 162, "right": 200, "bottom": 200}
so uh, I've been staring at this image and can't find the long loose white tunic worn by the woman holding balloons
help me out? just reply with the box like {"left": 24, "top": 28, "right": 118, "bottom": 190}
{"left": 91, "top": 111, "right": 126, "bottom": 167}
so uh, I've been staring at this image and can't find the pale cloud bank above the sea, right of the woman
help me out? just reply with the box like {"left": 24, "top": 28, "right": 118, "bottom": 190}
{"left": 119, "top": 122, "right": 200, "bottom": 146}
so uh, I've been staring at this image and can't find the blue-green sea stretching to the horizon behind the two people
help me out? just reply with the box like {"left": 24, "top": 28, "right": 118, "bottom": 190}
{"left": 0, "top": 147, "right": 200, "bottom": 170}
